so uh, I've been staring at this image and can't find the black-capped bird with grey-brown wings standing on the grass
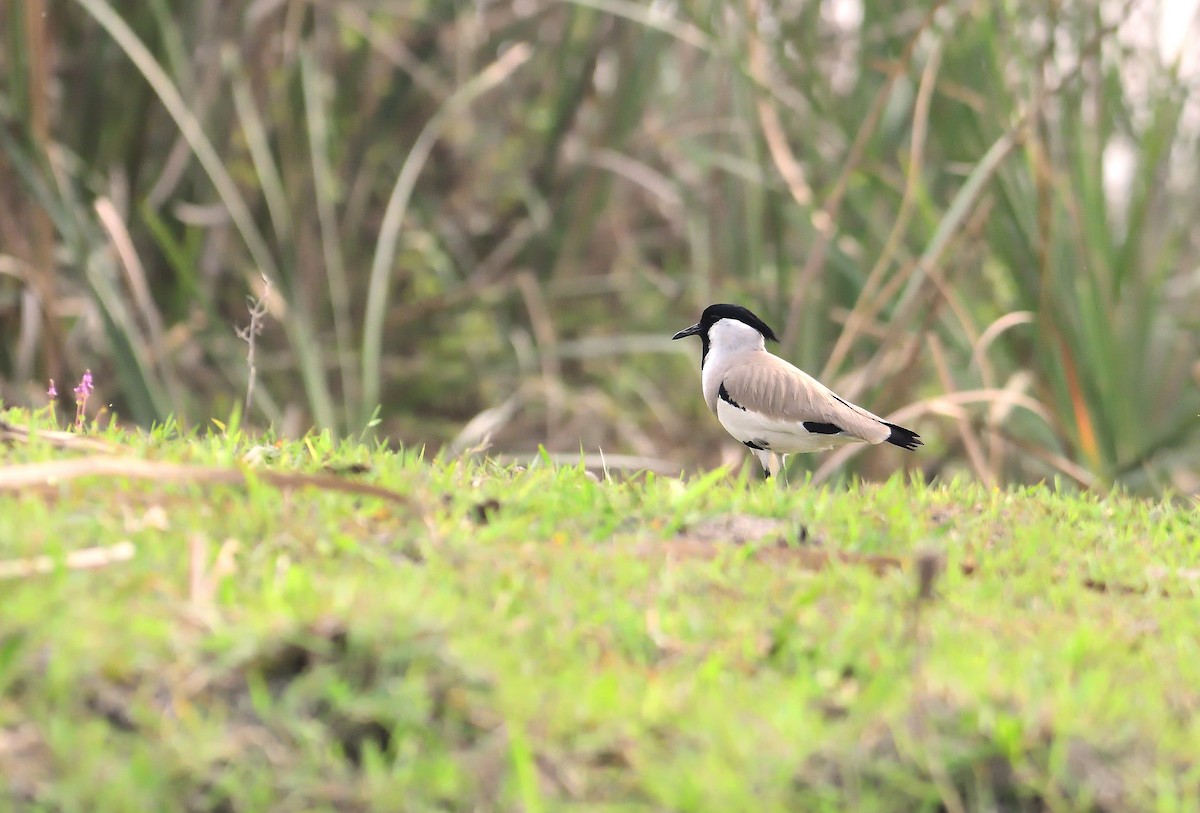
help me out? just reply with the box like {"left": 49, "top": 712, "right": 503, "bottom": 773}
{"left": 671, "top": 303, "right": 924, "bottom": 478}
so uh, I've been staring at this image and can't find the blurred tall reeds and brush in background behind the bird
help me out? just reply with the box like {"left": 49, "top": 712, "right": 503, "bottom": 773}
{"left": 0, "top": 0, "right": 1200, "bottom": 492}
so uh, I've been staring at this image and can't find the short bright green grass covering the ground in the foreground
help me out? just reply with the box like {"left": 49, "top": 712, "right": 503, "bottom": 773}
{"left": 0, "top": 411, "right": 1200, "bottom": 813}
